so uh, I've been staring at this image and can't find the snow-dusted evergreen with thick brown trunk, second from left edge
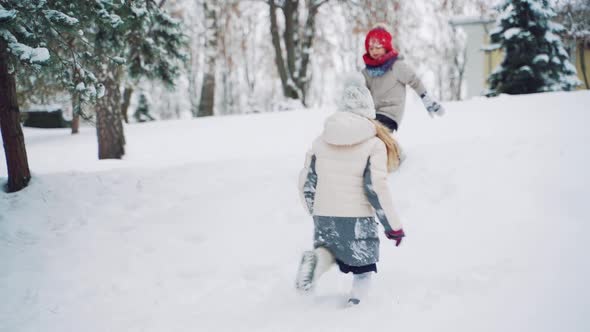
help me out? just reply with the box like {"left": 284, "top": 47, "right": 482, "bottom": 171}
{"left": 81, "top": 0, "right": 184, "bottom": 159}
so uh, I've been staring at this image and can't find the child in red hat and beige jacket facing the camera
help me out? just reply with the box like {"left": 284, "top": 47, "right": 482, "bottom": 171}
{"left": 362, "top": 24, "right": 444, "bottom": 132}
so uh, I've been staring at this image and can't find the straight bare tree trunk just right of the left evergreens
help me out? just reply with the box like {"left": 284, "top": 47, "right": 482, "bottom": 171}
{"left": 197, "top": 1, "right": 218, "bottom": 117}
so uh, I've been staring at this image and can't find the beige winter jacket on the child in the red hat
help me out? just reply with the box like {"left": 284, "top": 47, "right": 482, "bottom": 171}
{"left": 362, "top": 59, "right": 426, "bottom": 125}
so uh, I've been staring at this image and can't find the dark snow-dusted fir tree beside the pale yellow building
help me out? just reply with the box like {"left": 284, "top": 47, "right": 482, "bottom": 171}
{"left": 487, "top": 0, "right": 580, "bottom": 95}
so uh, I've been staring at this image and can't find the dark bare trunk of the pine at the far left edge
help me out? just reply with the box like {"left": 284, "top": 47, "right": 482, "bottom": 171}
{"left": 0, "top": 39, "right": 31, "bottom": 192}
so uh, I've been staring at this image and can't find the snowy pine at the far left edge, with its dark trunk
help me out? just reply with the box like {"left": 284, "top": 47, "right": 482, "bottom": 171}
{"left": 0, "top": 0, "right": 100, "bottom": 192}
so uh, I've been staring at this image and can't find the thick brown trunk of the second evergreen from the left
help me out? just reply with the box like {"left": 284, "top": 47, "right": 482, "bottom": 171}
{"left": 96, "top": 66, "right": 125, "bottom": 159}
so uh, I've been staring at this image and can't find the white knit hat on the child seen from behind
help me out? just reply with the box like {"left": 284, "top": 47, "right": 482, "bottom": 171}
{"left": 338, "top": 73, "right": 375, "bottom": 119}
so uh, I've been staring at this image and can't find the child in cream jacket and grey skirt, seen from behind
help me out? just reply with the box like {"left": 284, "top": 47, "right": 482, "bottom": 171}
{"left": 296, "top": 75, "right": 405, "bottom": 305}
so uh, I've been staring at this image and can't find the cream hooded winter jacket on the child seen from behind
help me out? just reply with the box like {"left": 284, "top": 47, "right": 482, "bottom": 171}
{"left": 299, "top": 112, "right": 402, "bottom": 230}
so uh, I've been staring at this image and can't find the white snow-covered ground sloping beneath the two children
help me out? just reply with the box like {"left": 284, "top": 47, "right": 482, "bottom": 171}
{"left": 0, "top": 91, "right": 590, "bottom": 332}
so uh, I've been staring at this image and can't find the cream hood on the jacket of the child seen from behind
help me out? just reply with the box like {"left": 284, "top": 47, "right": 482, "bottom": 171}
{"left": 321, "top": 112, "right": 377, "bottom": 145}
